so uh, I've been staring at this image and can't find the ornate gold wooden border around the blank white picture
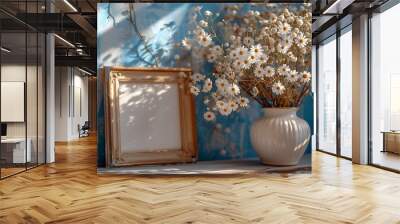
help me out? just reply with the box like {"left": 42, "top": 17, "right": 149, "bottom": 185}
{"left": 101, "top": 67, "right": 198, "bottom": 167}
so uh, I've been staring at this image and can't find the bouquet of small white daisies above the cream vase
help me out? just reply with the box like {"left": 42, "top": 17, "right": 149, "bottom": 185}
{"left": 182, "top": 4, "right": 311, "bottom": 121}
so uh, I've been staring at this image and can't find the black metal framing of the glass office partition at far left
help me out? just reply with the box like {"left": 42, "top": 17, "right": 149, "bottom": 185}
{"left": 0, "top": 0, "right": 47, "bottom": 180}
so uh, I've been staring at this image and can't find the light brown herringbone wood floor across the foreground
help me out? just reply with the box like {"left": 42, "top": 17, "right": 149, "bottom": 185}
{"left": 0, "top": 138, "right": 400, "bottom": 224}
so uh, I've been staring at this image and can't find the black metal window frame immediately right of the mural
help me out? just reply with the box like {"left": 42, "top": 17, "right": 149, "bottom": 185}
{"left": 315, "top": 24, "right": 352, "bottom": 160}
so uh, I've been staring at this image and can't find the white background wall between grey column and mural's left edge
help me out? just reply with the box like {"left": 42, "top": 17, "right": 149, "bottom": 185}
{"left": 55, "top": 67, "right": 88, "bottom": 141}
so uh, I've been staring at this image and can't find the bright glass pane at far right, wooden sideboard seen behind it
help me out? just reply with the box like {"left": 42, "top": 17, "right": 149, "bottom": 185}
{"left": 370, "top": 4, "right": 400, "bottom": 171}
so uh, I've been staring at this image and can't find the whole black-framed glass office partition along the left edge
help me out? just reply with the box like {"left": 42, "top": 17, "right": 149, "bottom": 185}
{"left": 0, "top": 1, "right": 46, "bottom": 179}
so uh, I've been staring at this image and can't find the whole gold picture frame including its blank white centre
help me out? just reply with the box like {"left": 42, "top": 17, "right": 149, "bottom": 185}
{"left": 102, "top": 67, "right": 198, "bottom": 167}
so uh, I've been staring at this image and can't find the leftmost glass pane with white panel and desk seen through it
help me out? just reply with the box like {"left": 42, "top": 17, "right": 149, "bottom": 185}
{"left": 0, "top": 32, "right": 27, "bottom": 177}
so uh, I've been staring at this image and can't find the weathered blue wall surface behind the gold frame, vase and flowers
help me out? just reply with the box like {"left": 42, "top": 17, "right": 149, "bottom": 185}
{"left": 97, "top": 3, "right": 313, "bottom": 166}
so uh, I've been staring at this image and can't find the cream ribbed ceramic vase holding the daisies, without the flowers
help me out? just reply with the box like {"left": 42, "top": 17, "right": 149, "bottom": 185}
{"left": 251, "top": 107, "right": 310, "bottom": 166}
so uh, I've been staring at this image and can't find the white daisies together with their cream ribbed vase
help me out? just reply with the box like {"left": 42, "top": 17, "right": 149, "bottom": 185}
{"left": 182, "top": 4, "right": 311, "bottom": 165}
